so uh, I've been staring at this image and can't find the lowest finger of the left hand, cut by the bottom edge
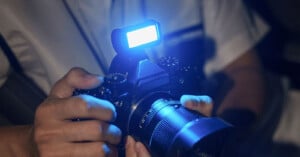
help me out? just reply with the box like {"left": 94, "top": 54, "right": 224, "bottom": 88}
{"left": 39, "top": 142, "right": 117, "bottom": 157}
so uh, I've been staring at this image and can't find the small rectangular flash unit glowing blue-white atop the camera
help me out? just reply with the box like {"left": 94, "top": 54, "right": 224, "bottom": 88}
{"left": 111, "top": 20, "right": 161, "bottom": 53}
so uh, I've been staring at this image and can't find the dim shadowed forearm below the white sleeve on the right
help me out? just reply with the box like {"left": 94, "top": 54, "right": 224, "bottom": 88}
{"left": 218, "top": 50, "right": 265, "bottom": 116}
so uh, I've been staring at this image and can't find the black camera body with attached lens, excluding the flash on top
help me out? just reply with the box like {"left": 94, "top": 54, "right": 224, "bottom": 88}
{"left": 74, "top": 55, "right": 231, "bottom": 157}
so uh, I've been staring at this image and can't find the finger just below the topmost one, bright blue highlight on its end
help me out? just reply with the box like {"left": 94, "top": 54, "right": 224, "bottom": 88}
{"left": 42, "top": 95, "right": 117, "bottom": 122}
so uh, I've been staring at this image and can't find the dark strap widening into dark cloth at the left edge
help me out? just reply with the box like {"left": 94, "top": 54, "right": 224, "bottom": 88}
{"left": 0, "top": 34, "right": 46, "bottom": 125}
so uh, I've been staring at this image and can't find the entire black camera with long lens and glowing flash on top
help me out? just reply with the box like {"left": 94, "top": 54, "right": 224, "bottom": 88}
{"left": 74, "top": 20, "right": 232, "bottom": 157}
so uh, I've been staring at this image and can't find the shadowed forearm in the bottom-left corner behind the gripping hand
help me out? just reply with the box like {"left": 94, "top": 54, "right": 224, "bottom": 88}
{"left": 0, "top": 125, "right": 35, "bottom": 157}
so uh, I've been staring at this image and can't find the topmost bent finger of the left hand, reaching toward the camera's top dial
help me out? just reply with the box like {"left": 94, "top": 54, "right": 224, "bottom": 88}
{"left": 50, "top": 68, "right": 103, "bottom": 98}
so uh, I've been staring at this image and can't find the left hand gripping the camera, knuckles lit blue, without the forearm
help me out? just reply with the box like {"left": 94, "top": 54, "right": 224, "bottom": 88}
{"left": 34, "top": 68, "right": 121, "bottom": 157}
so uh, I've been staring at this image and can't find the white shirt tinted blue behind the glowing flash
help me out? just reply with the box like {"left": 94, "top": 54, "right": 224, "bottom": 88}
{"left": 0, "top": 0, "right": 267, "bottom": 92}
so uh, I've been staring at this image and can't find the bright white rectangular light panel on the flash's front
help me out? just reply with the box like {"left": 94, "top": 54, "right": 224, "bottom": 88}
{"left": 126, "top": 25, "right": 158, "bottom": 48}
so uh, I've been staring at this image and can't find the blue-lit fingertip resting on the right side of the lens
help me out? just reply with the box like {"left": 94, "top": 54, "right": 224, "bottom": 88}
{"left": 180, "top": 95, "right": 213, "bottom": 116}
